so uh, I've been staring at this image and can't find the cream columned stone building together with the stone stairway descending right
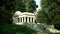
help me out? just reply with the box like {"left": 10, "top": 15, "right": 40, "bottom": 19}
{"left": 13, "top": 11, "right": 60, "bottom": 33}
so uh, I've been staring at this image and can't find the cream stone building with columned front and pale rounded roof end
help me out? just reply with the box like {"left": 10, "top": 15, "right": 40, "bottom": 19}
{"left": 13, "top": 11, "right": 36, "bottom": 25}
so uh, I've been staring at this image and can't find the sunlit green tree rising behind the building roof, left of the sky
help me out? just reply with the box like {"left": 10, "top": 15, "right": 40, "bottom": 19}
{"left": 24, "top": 0, "right": 38, "bottom": 13}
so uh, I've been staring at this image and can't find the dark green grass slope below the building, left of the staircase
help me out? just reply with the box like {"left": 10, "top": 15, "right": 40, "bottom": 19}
{"left": 0, "top": 25, "right": 35, "bottom": 34}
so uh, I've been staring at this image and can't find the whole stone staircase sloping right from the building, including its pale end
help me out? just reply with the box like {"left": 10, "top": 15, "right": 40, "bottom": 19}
{"left": 26, "top": 23, "right": 60, "bottom": 33}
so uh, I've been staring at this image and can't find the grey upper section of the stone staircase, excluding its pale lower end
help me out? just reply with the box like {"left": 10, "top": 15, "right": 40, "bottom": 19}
{"left": 26, "top": 23, "right": 47, "bottom": 32}
